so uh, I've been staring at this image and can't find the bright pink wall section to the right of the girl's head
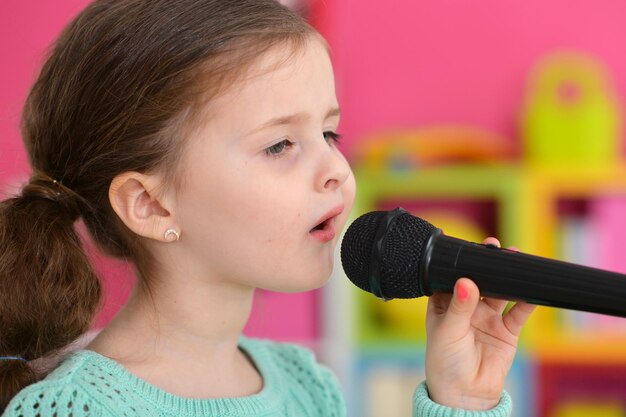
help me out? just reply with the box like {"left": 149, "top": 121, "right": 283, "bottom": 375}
{"left": 319, "top": 0, "right": 626, "bottom": 156}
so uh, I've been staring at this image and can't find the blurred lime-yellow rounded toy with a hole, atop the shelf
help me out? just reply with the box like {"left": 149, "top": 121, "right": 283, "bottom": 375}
{"left": 521, "top": 52, "right": 622, "bottom": 167}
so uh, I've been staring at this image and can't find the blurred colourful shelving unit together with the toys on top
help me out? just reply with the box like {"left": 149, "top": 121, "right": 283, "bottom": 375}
{"left": 336, "top": 51, "right": 626, "bottom": 417}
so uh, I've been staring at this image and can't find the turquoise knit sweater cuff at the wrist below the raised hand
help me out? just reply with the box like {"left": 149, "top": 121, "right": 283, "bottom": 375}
{"left": 413, "top": 382, "right": 512, "bottom": 417}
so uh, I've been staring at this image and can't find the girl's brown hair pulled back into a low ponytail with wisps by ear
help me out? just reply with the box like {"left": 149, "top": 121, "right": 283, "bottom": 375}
{"left": 0, "top": 0, "right": 315, "bottom": 412}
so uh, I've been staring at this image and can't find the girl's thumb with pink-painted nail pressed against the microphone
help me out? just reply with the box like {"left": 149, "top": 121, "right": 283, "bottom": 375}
{"left": 444, "top": 278, "right": 480, "bottom": 334}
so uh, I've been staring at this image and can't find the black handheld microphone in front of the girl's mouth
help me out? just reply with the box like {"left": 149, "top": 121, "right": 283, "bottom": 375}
{"left": 341, "top": 208, "right": 626, "bottom": 317}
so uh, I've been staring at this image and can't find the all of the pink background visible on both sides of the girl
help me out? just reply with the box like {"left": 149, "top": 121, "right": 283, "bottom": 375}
{"left": 0, "top": 0, "right": 626, "bottom": 339}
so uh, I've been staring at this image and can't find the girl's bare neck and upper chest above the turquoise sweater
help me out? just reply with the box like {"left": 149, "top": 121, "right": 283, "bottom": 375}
{"left": 88, "top": 254, "right": 263, "bottom": 398}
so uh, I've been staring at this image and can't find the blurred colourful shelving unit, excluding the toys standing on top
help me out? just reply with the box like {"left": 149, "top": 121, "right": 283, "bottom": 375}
{"left": 338, "top": 158, "right": 626, "bottom": 417}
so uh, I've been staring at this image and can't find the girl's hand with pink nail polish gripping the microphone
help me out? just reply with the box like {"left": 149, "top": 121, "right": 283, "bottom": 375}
{"left": 426, "top": 238, "right": 535, "bottom": 410}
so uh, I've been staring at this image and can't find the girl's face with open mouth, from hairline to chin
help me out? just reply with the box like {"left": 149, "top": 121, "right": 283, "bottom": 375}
{"left": 175, "top": 39, "right": 355, "bottom": 291}
